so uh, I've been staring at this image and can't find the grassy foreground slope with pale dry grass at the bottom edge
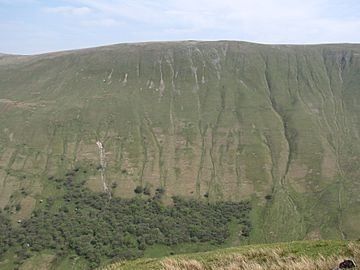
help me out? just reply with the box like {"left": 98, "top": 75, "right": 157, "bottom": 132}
{"left": 101, "top": 241, "right": 360, "bottom": 270}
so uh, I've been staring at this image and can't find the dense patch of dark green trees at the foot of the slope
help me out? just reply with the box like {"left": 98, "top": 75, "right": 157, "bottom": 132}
{"left": 0, "top": 170, "right": 251, "bottom": 268}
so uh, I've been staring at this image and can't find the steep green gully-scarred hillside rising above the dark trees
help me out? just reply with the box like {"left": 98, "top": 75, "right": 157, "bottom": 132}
{"left": 0, "top": 41, "right": 360, "bottom": 241}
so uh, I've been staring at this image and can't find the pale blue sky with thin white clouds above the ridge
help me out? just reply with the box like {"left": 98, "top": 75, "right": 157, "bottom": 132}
{"left": 0, "top": 0, "right": 360, "bottom": 54}
